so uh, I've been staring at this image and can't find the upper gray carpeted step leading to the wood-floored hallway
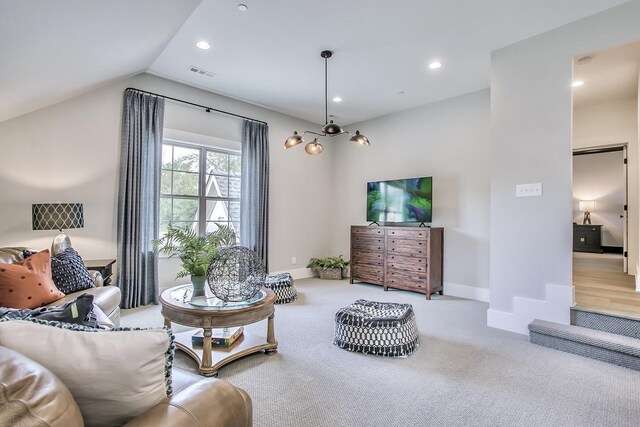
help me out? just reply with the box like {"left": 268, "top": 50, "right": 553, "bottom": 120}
{"left": 571, "top": 307, "right": 640, "bottom": 339}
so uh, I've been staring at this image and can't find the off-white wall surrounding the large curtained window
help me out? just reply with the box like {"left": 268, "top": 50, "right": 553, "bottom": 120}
{"left": 0, "top": 74, "right": 332, "bottom": 287}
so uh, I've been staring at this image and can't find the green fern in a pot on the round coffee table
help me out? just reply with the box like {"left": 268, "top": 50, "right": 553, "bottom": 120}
{"left": 153, "top": 224, "right": 236, "bottom": 294}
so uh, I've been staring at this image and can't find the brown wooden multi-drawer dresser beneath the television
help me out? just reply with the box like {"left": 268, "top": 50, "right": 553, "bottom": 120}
{"left": 350, "top": 225, "right": 443, "bottom": 299}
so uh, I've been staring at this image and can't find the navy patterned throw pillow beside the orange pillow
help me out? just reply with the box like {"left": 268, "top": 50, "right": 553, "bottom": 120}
{"left": 51, "top": 248, "right": 95, "bottom": 295}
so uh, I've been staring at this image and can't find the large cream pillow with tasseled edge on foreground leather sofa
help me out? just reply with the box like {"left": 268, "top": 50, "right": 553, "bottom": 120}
{"left": 0, "top": 319, "right": 175, "bottom": 426}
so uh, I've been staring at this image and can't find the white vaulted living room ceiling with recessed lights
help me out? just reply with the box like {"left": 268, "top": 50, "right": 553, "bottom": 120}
{"left": 0, "top": 0, "right": 625, "bottom": 125}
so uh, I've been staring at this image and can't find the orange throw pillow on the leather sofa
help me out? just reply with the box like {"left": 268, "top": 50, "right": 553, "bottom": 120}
{"left": 0, "top": 249, "right": 64, "bottom": 308}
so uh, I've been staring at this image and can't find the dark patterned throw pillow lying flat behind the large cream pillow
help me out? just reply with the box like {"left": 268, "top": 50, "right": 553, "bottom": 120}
{"left": 0, "top": 294, "right": 98, "bottom": 328}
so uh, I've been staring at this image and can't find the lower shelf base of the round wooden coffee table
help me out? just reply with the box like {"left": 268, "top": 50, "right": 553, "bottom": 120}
{"left": 175, "top": 329, "right": 278, "bottom": 377}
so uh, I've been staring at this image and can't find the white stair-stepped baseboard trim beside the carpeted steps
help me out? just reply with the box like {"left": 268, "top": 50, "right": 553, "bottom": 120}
{"left": 487, "top": 284, "right": 573, "bottom": 335}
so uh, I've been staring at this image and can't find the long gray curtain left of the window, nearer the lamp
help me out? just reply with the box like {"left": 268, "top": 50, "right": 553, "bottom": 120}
{"left": 118, "top": 89, "right": 164, "bottom": 308}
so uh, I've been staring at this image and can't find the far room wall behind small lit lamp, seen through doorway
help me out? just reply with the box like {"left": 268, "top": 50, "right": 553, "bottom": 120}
{"left": 573, "top": 151, "right": 624, "bottom": 249}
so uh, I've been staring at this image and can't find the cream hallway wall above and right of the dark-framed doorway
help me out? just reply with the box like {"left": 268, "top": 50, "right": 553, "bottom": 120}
{"left": 573, "top": 98, "right": 640, "bottom": 258}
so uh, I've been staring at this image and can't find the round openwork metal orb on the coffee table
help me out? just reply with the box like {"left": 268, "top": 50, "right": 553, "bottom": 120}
{"left": 207, "top": 246, "right": 267, "bottom": 302}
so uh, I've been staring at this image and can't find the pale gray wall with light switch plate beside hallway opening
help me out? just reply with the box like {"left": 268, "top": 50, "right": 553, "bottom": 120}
{"left": 487, "top": 1, "right": 640, "bottom": 333}
